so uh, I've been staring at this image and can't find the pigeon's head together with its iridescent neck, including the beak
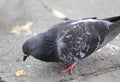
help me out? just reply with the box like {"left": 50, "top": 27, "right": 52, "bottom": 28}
{"left": 22, "top": 33, "right": 55, "bottom": 61}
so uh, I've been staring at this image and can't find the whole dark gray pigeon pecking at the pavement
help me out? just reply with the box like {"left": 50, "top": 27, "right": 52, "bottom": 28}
{"left": 22, "top": 16, "right": 120, "bottom": 74}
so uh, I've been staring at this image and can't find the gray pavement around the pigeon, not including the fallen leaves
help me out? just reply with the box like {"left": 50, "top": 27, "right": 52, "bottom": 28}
{"left": 0, "top": 0, "right": 120, "bottom": 82}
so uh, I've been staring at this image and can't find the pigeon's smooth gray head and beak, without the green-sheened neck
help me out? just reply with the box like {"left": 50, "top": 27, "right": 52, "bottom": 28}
{"left": 22, "top": 34, "right": 44, "bottom": 61}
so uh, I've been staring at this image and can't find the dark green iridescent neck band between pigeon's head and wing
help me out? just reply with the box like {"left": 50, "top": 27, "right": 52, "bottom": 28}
{"left": 37, "top": 37, "right": 58, "bottom": 62}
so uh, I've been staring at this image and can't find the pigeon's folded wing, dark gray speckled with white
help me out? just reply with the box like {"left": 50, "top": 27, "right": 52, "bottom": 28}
{"left": 57, "top": 20, "right": 109, "bottom": 62}
